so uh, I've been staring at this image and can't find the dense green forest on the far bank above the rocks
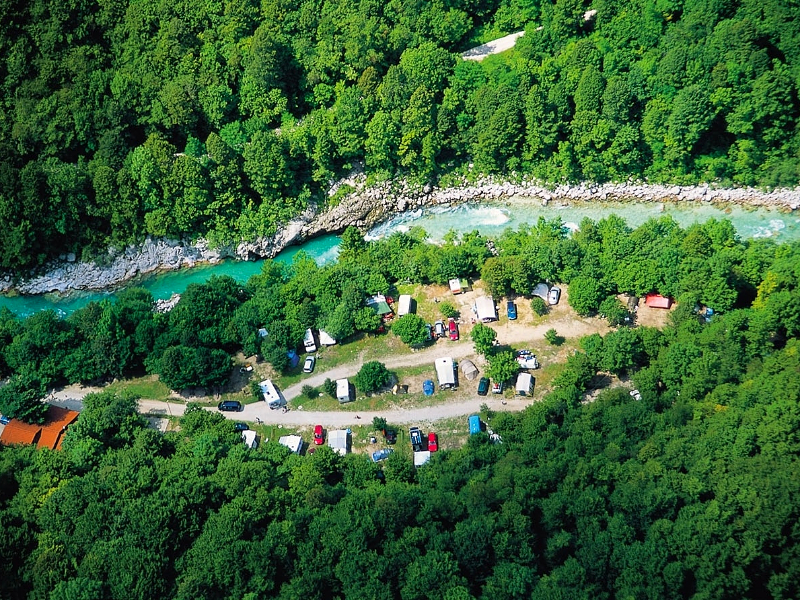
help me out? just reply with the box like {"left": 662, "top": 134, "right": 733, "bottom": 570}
{"left": 0, "top": 0, "right": 800, "bottom": 270}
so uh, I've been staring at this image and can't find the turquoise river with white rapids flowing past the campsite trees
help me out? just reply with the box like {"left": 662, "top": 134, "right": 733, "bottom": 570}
{"left": 0, "top": 198, "right": 800, "bottom": 316}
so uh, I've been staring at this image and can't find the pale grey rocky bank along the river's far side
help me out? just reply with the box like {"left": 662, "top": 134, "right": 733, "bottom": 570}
{"left": 0, "top": 174, "right": 800, "bottom": 294}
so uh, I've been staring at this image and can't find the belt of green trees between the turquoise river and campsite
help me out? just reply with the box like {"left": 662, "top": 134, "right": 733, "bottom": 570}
{"left": 6, "top": 216, "right": 800, "bottom": 421}
